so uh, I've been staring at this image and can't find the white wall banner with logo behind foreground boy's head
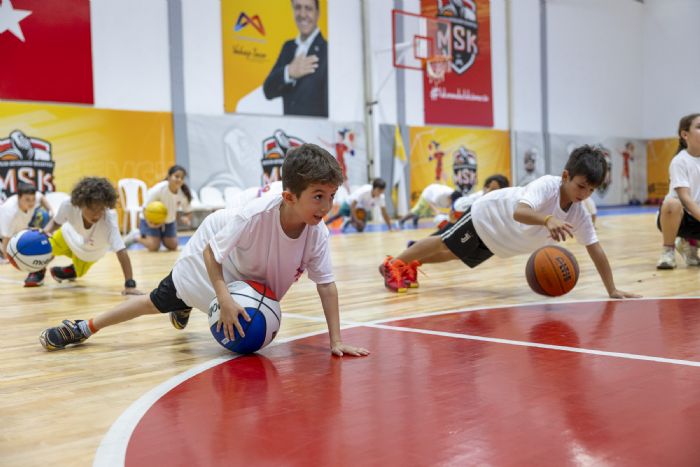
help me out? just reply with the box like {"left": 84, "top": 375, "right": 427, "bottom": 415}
{"left": 187, "top": 115, "right": 367, "bottom": 195}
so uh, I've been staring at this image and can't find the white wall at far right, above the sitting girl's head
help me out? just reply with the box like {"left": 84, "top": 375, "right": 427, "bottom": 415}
{"left": 640, "top": 0, "right": 700, "bottom": 138}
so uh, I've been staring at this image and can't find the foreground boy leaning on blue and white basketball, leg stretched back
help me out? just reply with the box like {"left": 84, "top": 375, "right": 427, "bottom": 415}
{"left": 40, "top": 144, "right": 369, "bottom": 356}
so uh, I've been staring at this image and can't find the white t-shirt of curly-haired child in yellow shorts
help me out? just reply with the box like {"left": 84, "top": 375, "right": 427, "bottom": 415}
{"left": 54, "top": 199, "right": 126, "bottom": 262}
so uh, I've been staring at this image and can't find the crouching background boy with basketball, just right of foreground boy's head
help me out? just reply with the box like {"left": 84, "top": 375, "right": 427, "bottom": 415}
{"left": 326, "top": 178, "right": 393, "bottom": 232}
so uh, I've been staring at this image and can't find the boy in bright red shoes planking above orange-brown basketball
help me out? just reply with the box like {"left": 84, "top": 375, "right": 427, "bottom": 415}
{"left": 379, "top": 146, "right": 637, "bottom": 298}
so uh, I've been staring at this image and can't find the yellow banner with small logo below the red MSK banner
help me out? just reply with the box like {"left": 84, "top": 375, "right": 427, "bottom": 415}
{"left": 409, "top": 127, "right": 512, "bottom": 203}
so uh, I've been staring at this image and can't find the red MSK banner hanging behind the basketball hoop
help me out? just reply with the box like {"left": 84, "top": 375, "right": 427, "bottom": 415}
{"left": 421, "top": 0, "right": 493, "bottom": 127}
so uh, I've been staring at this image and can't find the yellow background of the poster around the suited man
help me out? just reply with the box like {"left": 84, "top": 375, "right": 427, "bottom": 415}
{"left": 221, "top": 0, "right": 328, "bottom": 114}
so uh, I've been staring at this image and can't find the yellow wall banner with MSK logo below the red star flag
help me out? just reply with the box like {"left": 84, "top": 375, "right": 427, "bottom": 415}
{"left": 0, "top": 102, "right": 175, "bottom": 195}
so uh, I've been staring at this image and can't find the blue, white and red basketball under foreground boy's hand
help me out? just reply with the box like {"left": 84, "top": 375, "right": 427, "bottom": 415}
{"left": 208, "top": 281, "right": 282, "bottom": 354}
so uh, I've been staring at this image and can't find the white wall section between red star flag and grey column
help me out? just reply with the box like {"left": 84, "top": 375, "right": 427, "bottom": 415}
{"left": 90, "top": 0, "right": 171, "bottom": 111}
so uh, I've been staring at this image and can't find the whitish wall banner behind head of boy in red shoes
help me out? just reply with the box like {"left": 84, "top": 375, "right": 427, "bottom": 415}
{"left": 550, "top": 134, "right": 647, "bottom": 206}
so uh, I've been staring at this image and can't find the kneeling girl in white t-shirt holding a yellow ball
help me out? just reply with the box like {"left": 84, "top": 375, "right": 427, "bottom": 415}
{"left": 124, "top": 165, "right": 192, "bottom": 251}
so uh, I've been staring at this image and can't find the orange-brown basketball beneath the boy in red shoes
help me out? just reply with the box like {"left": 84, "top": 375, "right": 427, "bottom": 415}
{"left": 525, "top": 245, "right": 578, "bottom": 297}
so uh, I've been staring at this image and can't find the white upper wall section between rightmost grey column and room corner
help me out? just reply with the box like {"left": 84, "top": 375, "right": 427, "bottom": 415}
{"left": 547, "top": 0, "right": 644, "bottom": 137}
